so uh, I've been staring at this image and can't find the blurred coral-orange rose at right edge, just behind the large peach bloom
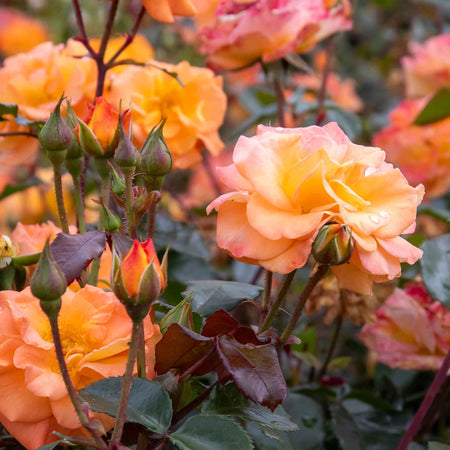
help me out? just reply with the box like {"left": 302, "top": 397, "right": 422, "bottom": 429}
{"left": 373, "top": 98, "right": 450, "bottom": 199}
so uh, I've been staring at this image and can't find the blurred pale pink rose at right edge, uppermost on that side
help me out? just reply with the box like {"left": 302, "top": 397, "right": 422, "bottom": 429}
{"left": 402, "top": 34, "right": 450, "bottom": 98}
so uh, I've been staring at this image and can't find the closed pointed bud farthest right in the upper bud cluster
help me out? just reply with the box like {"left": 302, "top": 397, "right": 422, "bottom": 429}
{"left": 139, "top": 122, "right": 172, "bottom": 178}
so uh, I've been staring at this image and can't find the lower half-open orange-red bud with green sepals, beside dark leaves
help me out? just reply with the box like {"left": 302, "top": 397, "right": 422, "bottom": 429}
{"left": 114, "top": 239, "right": 167, "bottom": 303}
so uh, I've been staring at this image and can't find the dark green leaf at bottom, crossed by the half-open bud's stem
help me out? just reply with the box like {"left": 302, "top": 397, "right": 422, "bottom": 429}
{"left": 80, "top": 377, "right": 172, "bottom": 434}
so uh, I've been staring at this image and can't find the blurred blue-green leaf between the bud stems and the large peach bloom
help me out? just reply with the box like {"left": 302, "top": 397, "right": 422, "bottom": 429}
{"left": 153, "top": 214, "right": 209, "bottom": 259}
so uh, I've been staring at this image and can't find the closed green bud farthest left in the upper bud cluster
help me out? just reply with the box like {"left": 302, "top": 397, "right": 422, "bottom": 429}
{"left": 39, "top": 97, "right": 72, "bottom": 164}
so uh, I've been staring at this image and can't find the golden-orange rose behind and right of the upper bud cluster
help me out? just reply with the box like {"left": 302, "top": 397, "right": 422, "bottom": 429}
{"left": 105, "top": 61, "right": 226, "bottom": 169}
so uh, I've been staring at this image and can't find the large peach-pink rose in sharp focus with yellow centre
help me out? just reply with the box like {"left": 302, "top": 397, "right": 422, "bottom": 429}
{"left": 208, "top": 123, "right": 424, "bottom": 294}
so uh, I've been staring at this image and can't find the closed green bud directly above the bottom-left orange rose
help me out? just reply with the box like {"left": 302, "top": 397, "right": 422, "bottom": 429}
{"left": 30, "top": 240, "right": 67, "bottom": 312}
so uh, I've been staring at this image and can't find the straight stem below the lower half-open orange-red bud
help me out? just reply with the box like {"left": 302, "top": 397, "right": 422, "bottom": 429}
{"left": 110, "top": 321, "right": 142, "bottom": 448}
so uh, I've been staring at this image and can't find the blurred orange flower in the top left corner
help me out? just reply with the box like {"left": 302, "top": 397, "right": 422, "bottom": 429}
{"left": 0, "top": 7, "right": 48, "bottom": 56}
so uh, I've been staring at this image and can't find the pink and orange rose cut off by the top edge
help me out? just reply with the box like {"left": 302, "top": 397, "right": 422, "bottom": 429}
{"left": 200, "top": 0, "right": 352, "bottom": 70}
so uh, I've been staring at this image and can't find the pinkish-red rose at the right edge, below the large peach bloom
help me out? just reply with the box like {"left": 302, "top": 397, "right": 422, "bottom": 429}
{"left": 359, "top": 284, "right": 450, "bottom": 370}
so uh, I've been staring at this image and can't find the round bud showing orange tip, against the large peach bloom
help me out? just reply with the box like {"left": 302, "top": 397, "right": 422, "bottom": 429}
{"left": 312, "top": 223, "right": 353, "bottom": 266}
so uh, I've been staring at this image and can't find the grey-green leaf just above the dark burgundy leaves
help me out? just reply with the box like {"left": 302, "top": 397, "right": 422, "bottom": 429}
{"left": 183, "top": 280, "right": 263, "bottom": 317}
